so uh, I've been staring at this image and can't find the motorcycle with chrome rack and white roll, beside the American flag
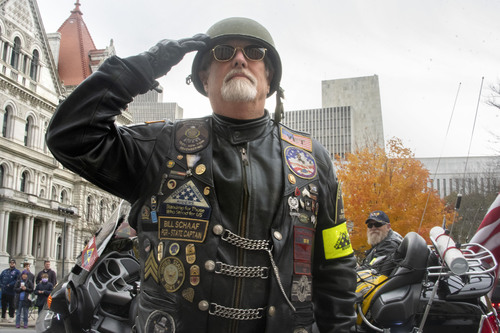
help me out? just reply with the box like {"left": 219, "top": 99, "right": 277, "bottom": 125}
{"left": 351, "top": 227, "right": 499, "bottom": 333}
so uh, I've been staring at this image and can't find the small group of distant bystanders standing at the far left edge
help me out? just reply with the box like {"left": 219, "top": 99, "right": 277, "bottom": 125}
{"left": 0, "top": 259, "right": 57, "bottom": 328}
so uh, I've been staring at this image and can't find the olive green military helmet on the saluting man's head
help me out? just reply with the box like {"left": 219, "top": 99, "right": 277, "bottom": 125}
{"left": 191, "top": 17, "right": 281, "bottom": 97}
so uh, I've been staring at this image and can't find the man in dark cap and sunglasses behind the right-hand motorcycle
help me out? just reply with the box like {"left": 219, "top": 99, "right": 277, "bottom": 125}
{"left": 361, "top": 210, "right": 403, "bottom": 275}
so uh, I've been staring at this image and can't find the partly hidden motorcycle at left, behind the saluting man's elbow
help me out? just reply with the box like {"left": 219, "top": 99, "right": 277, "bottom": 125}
{"left": 36, "top": 202, "right": 140, "bottom": 333}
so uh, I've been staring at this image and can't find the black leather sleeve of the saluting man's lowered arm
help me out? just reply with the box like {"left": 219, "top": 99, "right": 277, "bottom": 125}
{"left": 313, "top": 144, "right": 356, "bottom": 333}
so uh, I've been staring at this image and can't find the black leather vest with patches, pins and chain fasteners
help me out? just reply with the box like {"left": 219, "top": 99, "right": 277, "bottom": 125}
{"left": 132, "top": 117, "right": 320, "bottom": 332}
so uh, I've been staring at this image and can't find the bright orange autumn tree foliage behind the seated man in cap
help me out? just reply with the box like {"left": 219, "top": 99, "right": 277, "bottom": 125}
{"left": 335, "top": 138, "right": 453, "bottom": 253}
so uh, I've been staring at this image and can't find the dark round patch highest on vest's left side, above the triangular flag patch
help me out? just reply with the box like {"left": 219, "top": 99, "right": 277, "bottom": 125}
{"left": 175, "top": 119, "right": 209, "bottom": 154}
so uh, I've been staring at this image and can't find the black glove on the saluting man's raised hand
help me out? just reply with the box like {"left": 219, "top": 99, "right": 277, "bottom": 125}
{"left": 144, "top": 34, "right": 210, "bottom": 79}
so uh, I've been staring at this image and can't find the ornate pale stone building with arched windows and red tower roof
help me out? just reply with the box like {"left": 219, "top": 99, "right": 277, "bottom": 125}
{"left": 0, "top": 0, "right": 124, "bottom": 278}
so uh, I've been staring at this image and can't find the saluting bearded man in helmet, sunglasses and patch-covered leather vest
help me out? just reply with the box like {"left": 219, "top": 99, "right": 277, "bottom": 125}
{"left": 47, "top": 17, "right": 356, "bottom": 333}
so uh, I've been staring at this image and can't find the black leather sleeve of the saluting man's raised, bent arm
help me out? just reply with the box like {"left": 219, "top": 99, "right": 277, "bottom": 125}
{"left": 46, "top": 55, "right": 168, "bottom": 201}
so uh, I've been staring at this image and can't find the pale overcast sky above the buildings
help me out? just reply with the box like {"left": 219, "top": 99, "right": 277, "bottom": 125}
{"left": 38, "top": 0, "right": 500, "bottom": 157}
